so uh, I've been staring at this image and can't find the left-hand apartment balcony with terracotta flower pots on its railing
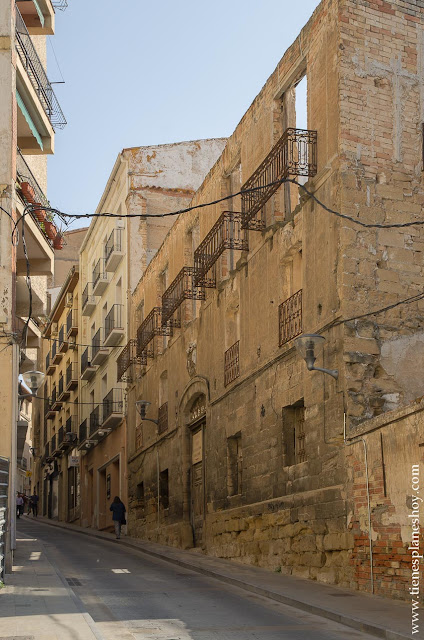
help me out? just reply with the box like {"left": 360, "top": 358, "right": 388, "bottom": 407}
{"left": 16, "top": 149, "right": 54, "bottom": 276}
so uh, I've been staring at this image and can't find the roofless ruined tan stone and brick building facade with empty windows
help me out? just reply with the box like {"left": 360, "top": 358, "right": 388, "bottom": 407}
{"left": 124, "top": 0, "right": 424, "bottom": 598}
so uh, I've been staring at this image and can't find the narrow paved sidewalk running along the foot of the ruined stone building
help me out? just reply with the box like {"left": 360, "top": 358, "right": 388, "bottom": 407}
{"left": 32, "top": 517, "right": 414, "bottom": 640}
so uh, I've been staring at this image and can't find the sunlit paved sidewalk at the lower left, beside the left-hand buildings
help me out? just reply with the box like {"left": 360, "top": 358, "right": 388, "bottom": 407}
{"left": 0, "top": 534, "right": 102, "bottom": 640}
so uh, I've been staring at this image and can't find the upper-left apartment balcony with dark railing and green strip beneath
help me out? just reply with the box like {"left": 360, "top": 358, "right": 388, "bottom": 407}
{"left": 16, "top": 7, "right": 66, "bottom": 155}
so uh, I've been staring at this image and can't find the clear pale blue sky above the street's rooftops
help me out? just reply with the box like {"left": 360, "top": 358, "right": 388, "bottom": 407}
{"left": 47, "top": 0, "right": 319, "bottom": 226}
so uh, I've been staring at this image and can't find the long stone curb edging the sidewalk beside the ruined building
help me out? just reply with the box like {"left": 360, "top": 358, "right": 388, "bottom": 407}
{"left": 31, "top": 519, "right": 412, "bottom": 640}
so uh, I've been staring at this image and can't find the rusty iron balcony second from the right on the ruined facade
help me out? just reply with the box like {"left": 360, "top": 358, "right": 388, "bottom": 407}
{"left": 193, "top": 211, "right": 249, "bottom": 287}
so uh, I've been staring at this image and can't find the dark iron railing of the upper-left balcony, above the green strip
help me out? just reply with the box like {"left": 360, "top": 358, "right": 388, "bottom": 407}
{"left": 16, "top": 7, "right": 66, "bottom": 129}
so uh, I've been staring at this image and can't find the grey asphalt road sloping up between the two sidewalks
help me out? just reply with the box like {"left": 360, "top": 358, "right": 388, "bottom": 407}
{"left": 19, "top": 518, "right": 375, "bottom": 640}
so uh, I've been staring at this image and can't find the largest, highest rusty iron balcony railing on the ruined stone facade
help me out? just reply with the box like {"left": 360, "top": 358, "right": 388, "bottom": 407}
{"left": 241, "top": 128, "right": 317, "bottom": 229}
